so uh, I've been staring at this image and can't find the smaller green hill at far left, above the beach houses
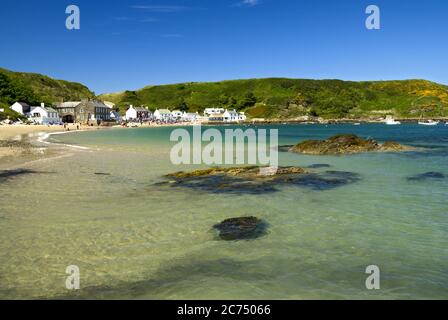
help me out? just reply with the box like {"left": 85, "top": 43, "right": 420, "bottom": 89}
{"left": 0, "top": 68, "right": 95, "bottom": 118}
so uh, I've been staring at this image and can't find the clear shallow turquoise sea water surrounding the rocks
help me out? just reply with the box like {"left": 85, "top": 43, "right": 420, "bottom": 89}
{"left": 0, "top": 124, "right": 448, "bottom": 299}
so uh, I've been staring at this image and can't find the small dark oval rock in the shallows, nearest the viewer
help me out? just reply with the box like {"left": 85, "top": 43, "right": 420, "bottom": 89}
{"left": 213, "top": 217, "right": 267, "bottom": 241}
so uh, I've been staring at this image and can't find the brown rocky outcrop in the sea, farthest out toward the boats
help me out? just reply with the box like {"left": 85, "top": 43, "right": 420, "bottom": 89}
{"left": 289, "top": 134, "right": 412, "bottom": 155}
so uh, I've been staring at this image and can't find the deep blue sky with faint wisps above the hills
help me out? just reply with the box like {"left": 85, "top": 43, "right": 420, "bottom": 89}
{"left": 0, "top": 0, "right": 448, "bottom": 94}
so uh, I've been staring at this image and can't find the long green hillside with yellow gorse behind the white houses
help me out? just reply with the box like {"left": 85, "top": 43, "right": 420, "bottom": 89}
{"left": 100, "top": 78, "right": 448, "bottom": 119}
